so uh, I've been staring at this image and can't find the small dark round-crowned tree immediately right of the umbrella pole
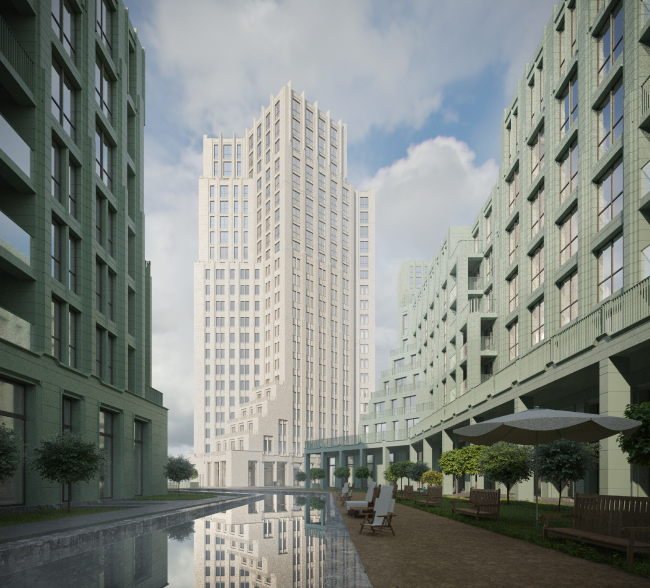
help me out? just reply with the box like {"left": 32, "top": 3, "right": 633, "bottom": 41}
{"left": 538, "top": 439, "right": 599, "bottom": 508}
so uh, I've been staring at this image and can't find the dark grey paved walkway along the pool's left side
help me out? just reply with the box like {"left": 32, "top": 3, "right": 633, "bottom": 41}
{"left": 0, "top": 496, "right": 238, "bottom": 544}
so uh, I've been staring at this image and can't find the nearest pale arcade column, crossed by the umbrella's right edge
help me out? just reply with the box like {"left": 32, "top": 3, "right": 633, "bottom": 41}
{"left": 599, "top": 358, "right": 632, "bottom": 496}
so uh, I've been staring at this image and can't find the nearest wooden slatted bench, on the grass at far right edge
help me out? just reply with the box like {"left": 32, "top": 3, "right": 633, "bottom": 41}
{"left": 540, "top": 493, "right": 650, "bottom": 563}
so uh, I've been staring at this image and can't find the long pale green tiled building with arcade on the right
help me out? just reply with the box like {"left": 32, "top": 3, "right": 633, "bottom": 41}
{"left": 307, "top": 0, "right": 650, "bottom": 499}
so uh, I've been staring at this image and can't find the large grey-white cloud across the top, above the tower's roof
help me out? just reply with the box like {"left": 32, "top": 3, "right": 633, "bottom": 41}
{"left": 139, "top": 0, "right": 553, "bottom": 140}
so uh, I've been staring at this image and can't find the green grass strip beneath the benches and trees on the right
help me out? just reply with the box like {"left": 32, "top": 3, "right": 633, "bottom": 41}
{"left": 398, "top": 496, "right": 650, "bottom": 578}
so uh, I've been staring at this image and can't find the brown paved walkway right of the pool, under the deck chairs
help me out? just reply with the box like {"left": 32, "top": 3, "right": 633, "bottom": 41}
{"left": 339, "top": 495, "right": 650, "bottom": 588}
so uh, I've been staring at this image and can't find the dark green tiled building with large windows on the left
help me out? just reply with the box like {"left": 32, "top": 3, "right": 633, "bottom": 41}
{"left": 0, "top": 0, "right": 167, "bottom": 504}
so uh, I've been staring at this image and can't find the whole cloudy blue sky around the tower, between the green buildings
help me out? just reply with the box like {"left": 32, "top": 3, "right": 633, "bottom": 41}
{"left": 126, "top": 0, "right": 555, "bottom": 455}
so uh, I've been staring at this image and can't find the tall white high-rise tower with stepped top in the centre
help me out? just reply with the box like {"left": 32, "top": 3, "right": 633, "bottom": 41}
{"left": 193, "top": 84, "right": 375, "bottom": 486}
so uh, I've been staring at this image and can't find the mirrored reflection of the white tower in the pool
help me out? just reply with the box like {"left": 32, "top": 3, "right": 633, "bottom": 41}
{"left": 194, "top": 494, "right": 363, "bottom": 588}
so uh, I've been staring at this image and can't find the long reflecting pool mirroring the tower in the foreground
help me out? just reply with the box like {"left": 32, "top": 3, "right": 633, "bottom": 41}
{"left": 0, "top": 493, "right": 371, "bottom": 588}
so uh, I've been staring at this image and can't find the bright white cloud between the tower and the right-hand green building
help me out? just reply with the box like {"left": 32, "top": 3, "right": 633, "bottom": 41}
{"left": 361, "top": 137, "right": 498, "bottom": 373}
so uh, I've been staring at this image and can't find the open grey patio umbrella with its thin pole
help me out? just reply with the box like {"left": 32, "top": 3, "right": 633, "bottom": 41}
{"left": 454, "top": 406, "right": 641, "bottom": 528}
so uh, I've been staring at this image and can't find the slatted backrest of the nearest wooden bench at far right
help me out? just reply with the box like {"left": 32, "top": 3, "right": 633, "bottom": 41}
{"left": 573, "top": 493, "right": 650, "bottom": 541}
